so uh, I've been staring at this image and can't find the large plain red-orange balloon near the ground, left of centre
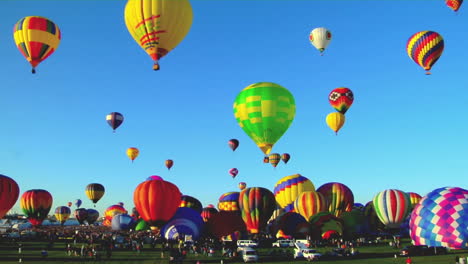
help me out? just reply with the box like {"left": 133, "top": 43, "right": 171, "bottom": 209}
{"left": 133, "top": 180, "right": 182, "bottom": 232}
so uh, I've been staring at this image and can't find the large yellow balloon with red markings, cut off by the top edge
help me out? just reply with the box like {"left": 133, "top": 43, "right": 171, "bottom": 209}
{"left": 125, "top": 0, "right": 192, "bottom": 70}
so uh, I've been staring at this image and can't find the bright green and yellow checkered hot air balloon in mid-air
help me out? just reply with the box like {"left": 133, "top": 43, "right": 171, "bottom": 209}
{"left": 234, "top": 82, "right": 296, "bottom": 155}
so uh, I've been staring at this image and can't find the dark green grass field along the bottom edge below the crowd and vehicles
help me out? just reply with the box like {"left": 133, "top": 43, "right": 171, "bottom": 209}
{"left": 0, "top": 242, "right": 468, "bottom": 264}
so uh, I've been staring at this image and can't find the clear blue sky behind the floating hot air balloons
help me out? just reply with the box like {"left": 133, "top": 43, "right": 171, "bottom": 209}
{"left": 0, "top": 0, "right": 468, "bottom": 217}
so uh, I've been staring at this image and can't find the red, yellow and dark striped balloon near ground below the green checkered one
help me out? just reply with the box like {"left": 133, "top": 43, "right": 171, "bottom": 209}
{"left": 239, "top": 187, "right": 276, "bottom": 234}
